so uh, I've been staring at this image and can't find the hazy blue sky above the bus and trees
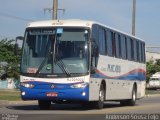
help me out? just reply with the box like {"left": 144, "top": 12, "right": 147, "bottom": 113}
{"left": 0, "top": 0, "right": 160, "bottom": 46}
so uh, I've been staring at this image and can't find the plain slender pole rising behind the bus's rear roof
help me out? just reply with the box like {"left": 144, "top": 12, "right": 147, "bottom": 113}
{"left": 132, "top": 0, "right": 136, "bottom": 36}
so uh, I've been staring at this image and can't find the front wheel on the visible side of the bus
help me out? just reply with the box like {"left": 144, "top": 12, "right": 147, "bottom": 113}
{"left": 95, "top": 84, "right": 105, "bottom": 109}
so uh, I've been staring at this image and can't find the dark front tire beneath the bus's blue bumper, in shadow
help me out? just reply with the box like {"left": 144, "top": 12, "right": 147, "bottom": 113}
{"left": 38, "top": 100, "right": 51, "bottom": 110}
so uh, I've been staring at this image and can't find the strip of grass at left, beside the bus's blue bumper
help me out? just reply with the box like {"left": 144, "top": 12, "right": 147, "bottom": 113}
{"left": 0, "top": 90, "right": 21, "bottom": 101}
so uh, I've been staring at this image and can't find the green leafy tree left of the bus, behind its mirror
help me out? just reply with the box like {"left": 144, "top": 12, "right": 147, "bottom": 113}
{"left": 0, "top": 39, "right": 21, "bottom": 79}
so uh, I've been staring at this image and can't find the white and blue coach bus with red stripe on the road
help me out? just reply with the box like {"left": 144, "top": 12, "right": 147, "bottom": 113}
{"left": 20, "top": 20, "right": 146, "bottom": 109}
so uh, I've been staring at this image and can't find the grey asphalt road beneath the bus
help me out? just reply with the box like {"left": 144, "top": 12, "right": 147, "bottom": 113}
{"left": 0, "top": 95, "right": 160, "bottom": 120}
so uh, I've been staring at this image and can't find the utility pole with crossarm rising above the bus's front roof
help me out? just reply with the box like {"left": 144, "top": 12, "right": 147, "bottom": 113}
{"left": 44, "top": 0, "right": 65, "bottom": 20}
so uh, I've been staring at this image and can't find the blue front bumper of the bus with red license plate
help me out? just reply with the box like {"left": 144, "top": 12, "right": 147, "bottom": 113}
{"left": 20, "top": 86, "right": 89, "bottom": 101}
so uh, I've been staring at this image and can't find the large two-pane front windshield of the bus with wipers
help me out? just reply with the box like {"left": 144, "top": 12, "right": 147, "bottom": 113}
{"left": 21, "top": 28, "right": 89, "bottom": 75}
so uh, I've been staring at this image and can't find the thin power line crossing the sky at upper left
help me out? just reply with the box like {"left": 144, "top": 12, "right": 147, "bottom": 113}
{"left": 0, "top": 12, "right": 34, "bottom": 22}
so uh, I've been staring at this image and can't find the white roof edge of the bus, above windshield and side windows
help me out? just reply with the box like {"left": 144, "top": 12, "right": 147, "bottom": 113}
{"left": 27, "top": 19, "right": 143, "bottom": 41}
